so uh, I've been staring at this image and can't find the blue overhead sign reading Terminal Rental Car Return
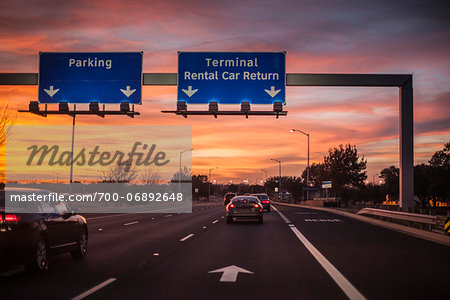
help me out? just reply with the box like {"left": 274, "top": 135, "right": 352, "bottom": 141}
{"left": 178, "top": 52, "right": 286, "bottom": 104}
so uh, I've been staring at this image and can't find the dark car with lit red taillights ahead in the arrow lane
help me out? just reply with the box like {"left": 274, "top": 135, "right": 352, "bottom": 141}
{"left": 226, "top": 196, "right": 263, "bottom": 224}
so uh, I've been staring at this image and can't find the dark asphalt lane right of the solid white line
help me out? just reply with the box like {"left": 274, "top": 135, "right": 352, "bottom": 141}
{"left": 277, "top": 205, "right": 450, "bottom": 299}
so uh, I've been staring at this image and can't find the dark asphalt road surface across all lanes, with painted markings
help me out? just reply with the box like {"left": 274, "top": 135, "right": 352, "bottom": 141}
{"left": 0, "top": 202, "right": 450, "bottom": 299}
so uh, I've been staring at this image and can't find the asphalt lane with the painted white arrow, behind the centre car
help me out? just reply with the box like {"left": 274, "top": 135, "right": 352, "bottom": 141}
{"left": 94, "top": 206, "right": 345, "bottom": 299}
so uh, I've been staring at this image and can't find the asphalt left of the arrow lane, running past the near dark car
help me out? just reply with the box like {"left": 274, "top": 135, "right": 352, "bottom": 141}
{"left": 0, "top": 203, "right": 223, "bottom": 299}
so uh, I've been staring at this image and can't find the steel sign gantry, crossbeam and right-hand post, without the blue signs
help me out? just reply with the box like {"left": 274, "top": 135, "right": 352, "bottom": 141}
{"left": 0, "top": 54, "right": 414, "bottom": 210}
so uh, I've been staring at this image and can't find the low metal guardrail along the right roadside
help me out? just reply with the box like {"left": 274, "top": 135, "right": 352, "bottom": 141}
{"left": 357, "top": 208, "right": 438, "bottom": 230}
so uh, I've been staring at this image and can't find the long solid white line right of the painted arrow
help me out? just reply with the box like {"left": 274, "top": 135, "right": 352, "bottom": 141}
{"left": 272, "top": 206, "right": 366, "bottom": 300}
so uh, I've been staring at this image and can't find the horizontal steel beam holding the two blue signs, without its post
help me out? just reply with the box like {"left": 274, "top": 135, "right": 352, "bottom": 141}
{"left": 0, "top": 73, "right": 412, "bottom": 87}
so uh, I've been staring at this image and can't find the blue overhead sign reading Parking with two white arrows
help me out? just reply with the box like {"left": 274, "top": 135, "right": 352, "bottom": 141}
{"left": 38, "top": 52, "right": 143, "bottom": 104}
